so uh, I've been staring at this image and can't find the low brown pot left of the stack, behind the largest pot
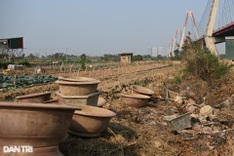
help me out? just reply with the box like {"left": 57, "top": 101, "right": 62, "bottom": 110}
{"left": 15, "top": 92, "right": 51, "bottom": 103}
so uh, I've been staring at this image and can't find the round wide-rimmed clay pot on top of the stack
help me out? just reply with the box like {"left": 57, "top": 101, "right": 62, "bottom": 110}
{"left": 55, "top": 80, "right": 100, "bottom": 96}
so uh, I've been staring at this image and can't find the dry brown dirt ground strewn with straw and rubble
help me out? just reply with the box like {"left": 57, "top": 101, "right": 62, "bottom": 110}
{"left": 0, "top": 62, "right": 234, "bottom": 156}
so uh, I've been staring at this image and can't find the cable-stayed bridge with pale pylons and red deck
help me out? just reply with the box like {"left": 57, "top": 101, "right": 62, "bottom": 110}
{"left": 168, "top": 0, "right": 234, "bottom": 60}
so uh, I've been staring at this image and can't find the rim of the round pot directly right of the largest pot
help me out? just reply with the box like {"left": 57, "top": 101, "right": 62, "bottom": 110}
{"left": 74, "top": 104, "right": 116, "bottom": 117}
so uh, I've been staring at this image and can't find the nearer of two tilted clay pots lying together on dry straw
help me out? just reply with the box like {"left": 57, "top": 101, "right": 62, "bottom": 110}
{"left": 122, "top": 94, "right": 150, "bottom": 107}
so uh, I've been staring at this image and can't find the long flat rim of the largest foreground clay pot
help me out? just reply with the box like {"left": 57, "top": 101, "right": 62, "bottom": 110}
{"left": 0, "top": 102, "right": 80, "bottom": 110}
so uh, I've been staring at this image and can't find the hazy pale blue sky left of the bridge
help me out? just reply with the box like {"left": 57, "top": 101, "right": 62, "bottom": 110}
{"left": 0, "top": 0, "right": 207, "bottom": 56}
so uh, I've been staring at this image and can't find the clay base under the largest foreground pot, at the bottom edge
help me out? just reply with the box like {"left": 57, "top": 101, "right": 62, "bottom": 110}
{"left": 0, "top": 146, "right": 63, "bottom": 156}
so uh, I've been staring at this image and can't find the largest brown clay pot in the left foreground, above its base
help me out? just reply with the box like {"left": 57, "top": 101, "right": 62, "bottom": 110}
{"left": 0, "top": 102, "right": 77, "bottom": 147}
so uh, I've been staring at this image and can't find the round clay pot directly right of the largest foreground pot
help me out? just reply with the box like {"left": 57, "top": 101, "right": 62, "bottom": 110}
{"left": 68, "top": 105, "right": 116, "bottom": 137}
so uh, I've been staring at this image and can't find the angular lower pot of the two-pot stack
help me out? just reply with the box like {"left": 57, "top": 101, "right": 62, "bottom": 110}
{"left": 55, "top": 91, "right": 101, "bottom": 106}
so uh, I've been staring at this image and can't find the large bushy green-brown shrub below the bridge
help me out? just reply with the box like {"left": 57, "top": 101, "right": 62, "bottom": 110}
{"left": 182, "top": 42, "right": 230, "bottom": 82}
